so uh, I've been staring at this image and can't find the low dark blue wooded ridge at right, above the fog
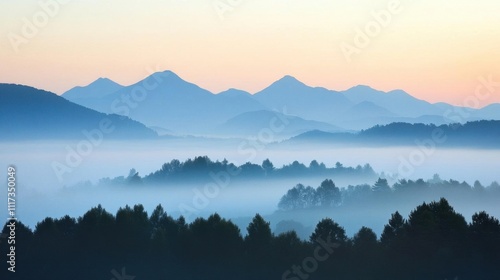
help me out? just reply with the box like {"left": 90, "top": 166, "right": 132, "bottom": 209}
{"left": 287, "top": 120, "right": 500, "bottom": 148}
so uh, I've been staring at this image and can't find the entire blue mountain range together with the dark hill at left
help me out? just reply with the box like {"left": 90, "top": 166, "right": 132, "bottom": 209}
{"left": 0, "top": 71, "right": 500, "bottom": 140}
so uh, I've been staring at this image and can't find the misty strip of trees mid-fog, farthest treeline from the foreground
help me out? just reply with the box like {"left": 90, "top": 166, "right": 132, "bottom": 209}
{"left": 92, "top": 156, "right": 377, "bottom": 186}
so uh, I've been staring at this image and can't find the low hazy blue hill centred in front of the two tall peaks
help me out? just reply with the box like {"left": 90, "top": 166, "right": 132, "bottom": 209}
{"left": 215, "top": 110, "right": 342, "bottom": 141}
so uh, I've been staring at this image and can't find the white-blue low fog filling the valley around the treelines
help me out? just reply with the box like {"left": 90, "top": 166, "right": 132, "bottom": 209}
{"left": 0, "top": 138, "right": 500, "bottom": 235}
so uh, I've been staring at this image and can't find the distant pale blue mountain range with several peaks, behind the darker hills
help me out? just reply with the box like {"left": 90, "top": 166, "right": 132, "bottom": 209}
{"left": 58, "top": 71, "right": 500, "bottom": 135}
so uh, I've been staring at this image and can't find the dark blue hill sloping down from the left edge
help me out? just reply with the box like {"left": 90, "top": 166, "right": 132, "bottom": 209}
{"left": 0, "top": 84, "right": 156, "bottom": 140}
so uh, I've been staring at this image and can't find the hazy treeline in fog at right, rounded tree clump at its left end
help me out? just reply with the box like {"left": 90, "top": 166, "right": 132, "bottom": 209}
{"left": 278, "top": 175, "right": 500, "bottom": 210}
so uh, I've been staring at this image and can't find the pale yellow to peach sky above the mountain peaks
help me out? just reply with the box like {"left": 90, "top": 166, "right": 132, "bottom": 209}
{"left": 0, "top": 0, "right": 500, "bottom": 107}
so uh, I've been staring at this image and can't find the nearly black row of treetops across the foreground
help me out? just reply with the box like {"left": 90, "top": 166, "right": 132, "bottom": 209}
{"left": 0, "top": 199, "right": 500, "bottom": 280}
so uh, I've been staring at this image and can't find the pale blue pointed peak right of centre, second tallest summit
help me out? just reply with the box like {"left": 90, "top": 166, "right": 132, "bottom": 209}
{"left": 254, "top": 76, "right": 354, "bottom": 123}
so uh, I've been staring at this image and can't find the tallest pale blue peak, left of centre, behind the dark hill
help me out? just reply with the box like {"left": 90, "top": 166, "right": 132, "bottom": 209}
{"left": 67, "top": 71, "right": 266, "bottom": 134}
